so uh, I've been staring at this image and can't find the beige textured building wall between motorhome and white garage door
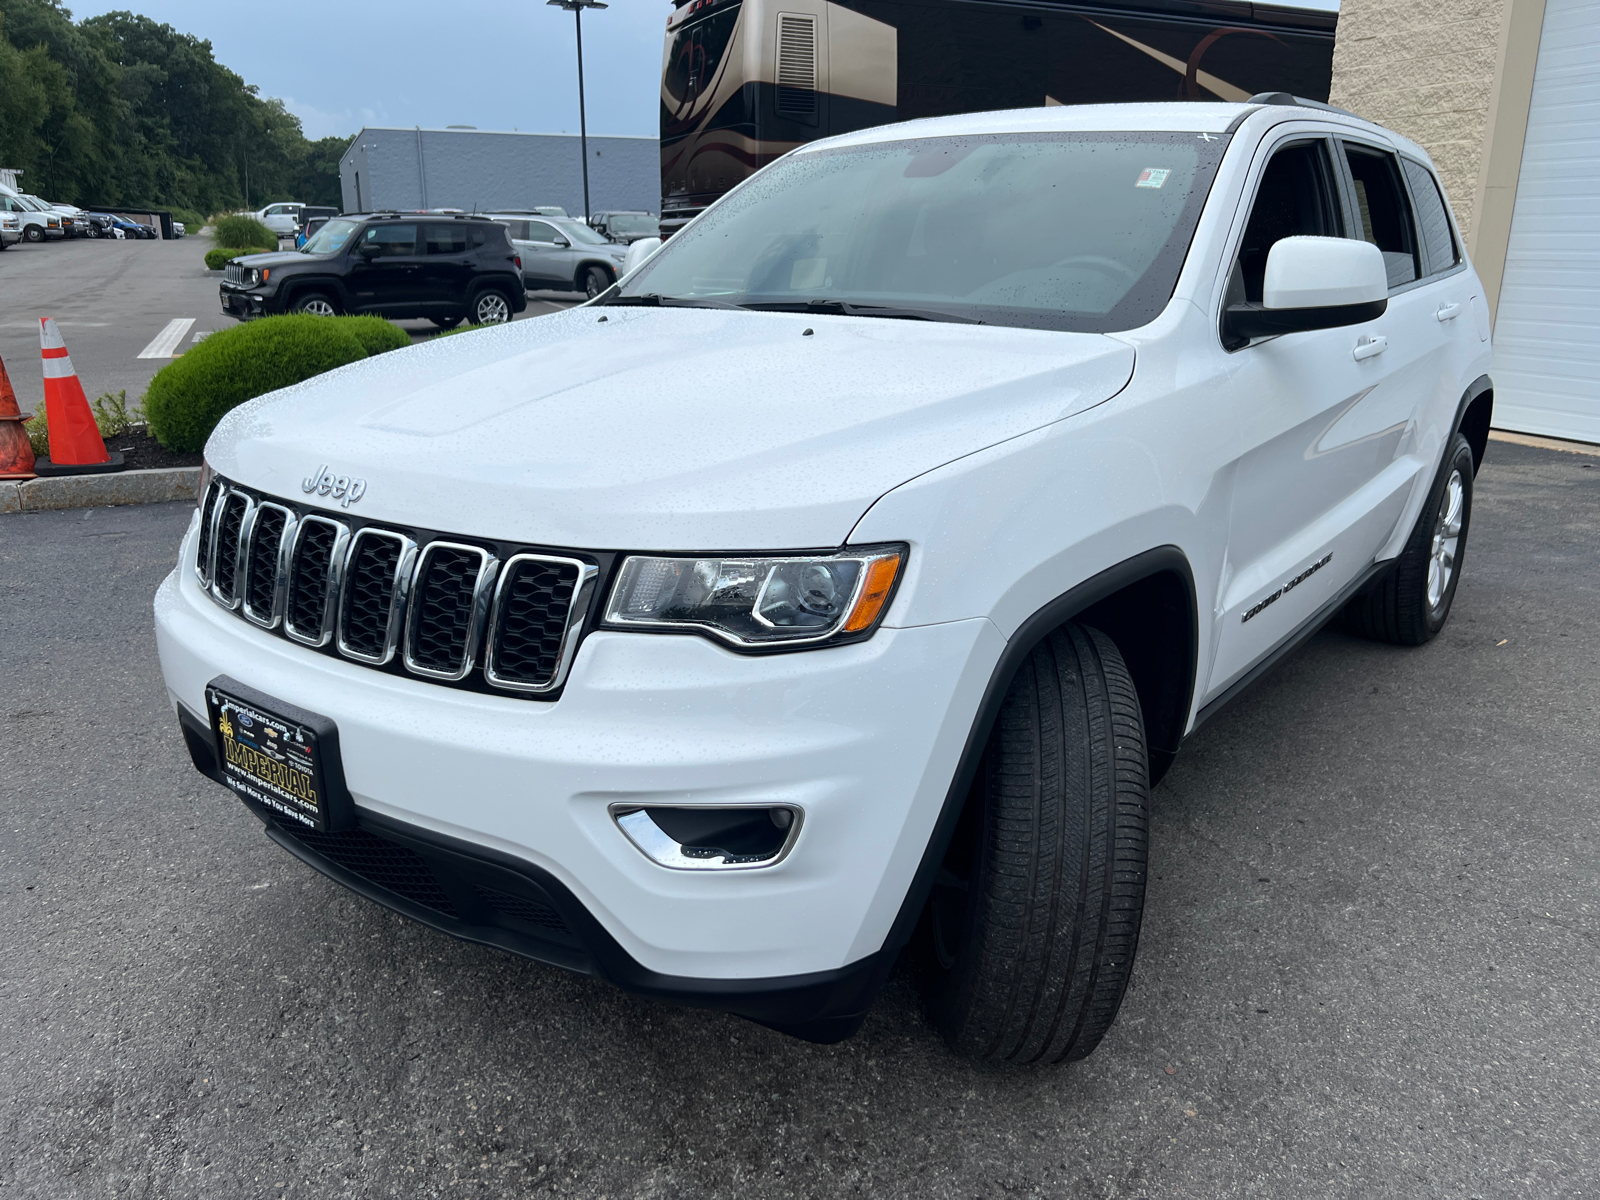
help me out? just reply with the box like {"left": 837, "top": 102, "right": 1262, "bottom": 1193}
{"left": 1330, "top": 0, "right": 1544, "bottom": 321}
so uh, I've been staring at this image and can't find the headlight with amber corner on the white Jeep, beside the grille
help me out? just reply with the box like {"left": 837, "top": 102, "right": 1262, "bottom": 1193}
{"left": 605, "top": 546, "right": 906, "bottom": 650}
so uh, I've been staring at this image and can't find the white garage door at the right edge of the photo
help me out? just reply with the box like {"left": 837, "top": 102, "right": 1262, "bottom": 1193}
{"left": 1494, "top": 0, "right": 1600, "bottom": 442}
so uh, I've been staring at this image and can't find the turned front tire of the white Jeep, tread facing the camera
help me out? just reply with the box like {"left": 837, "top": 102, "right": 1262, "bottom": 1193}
{"left": 923, "top": 624, "right": 1149, "bottom": 1062}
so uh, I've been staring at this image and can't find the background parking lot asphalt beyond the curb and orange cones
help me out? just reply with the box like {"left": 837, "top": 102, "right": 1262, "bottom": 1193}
{"left": 0, "top": 235, "right": 582, "bottom": 413}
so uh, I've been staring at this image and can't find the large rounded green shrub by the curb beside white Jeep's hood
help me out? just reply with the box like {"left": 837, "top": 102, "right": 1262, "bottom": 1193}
{"left": 144, "top": 314, "right": 366, "bottom": 451}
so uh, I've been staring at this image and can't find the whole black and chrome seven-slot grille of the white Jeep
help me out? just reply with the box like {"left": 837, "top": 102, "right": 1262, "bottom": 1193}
{"left": 195, "top": 477, "right": 600, "bottom": 698}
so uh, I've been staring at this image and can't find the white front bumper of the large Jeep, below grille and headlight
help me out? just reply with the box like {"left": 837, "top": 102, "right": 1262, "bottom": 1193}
{"left": 155, "top": 518, "right": 1002, "bottom": 1024}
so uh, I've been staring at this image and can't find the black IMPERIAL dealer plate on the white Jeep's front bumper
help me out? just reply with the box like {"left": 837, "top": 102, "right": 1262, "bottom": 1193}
{"left": 206, "top": 675, "right": 352, "bottom": 832}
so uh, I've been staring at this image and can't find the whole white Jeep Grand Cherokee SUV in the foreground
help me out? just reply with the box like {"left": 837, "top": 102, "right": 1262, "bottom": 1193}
{"left": 155, "top": 94, "right": 1491, "bottom": 1061}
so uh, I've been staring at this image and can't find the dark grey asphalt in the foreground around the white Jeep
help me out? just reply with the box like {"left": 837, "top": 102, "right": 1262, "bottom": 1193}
{"left": 0, "top": 441, "right": 1600, "bottom": 1200}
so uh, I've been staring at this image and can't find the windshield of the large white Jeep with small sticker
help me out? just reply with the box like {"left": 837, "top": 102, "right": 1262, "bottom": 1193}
{"left": 622, "top": 133, "right": 1227, "bottom": 333}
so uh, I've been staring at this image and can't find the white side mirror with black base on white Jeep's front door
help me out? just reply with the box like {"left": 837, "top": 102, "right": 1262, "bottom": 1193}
{"left": 1222, "top": 237, "right": 1389, "bottom": 346}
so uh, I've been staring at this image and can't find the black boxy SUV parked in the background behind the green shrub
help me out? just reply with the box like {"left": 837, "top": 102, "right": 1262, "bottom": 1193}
{"left": 221, "top": 213, "right": 528, "bottom": 330}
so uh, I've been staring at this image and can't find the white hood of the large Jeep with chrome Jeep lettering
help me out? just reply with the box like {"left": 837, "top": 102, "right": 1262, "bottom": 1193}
{"left": 206, "top": 306, "right": 1133, "bottom": 550}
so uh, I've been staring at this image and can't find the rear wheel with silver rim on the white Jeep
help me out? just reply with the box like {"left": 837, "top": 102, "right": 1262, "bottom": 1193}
{"left": 1344, "top": 434, "right": 1474, "bottom": 646}
